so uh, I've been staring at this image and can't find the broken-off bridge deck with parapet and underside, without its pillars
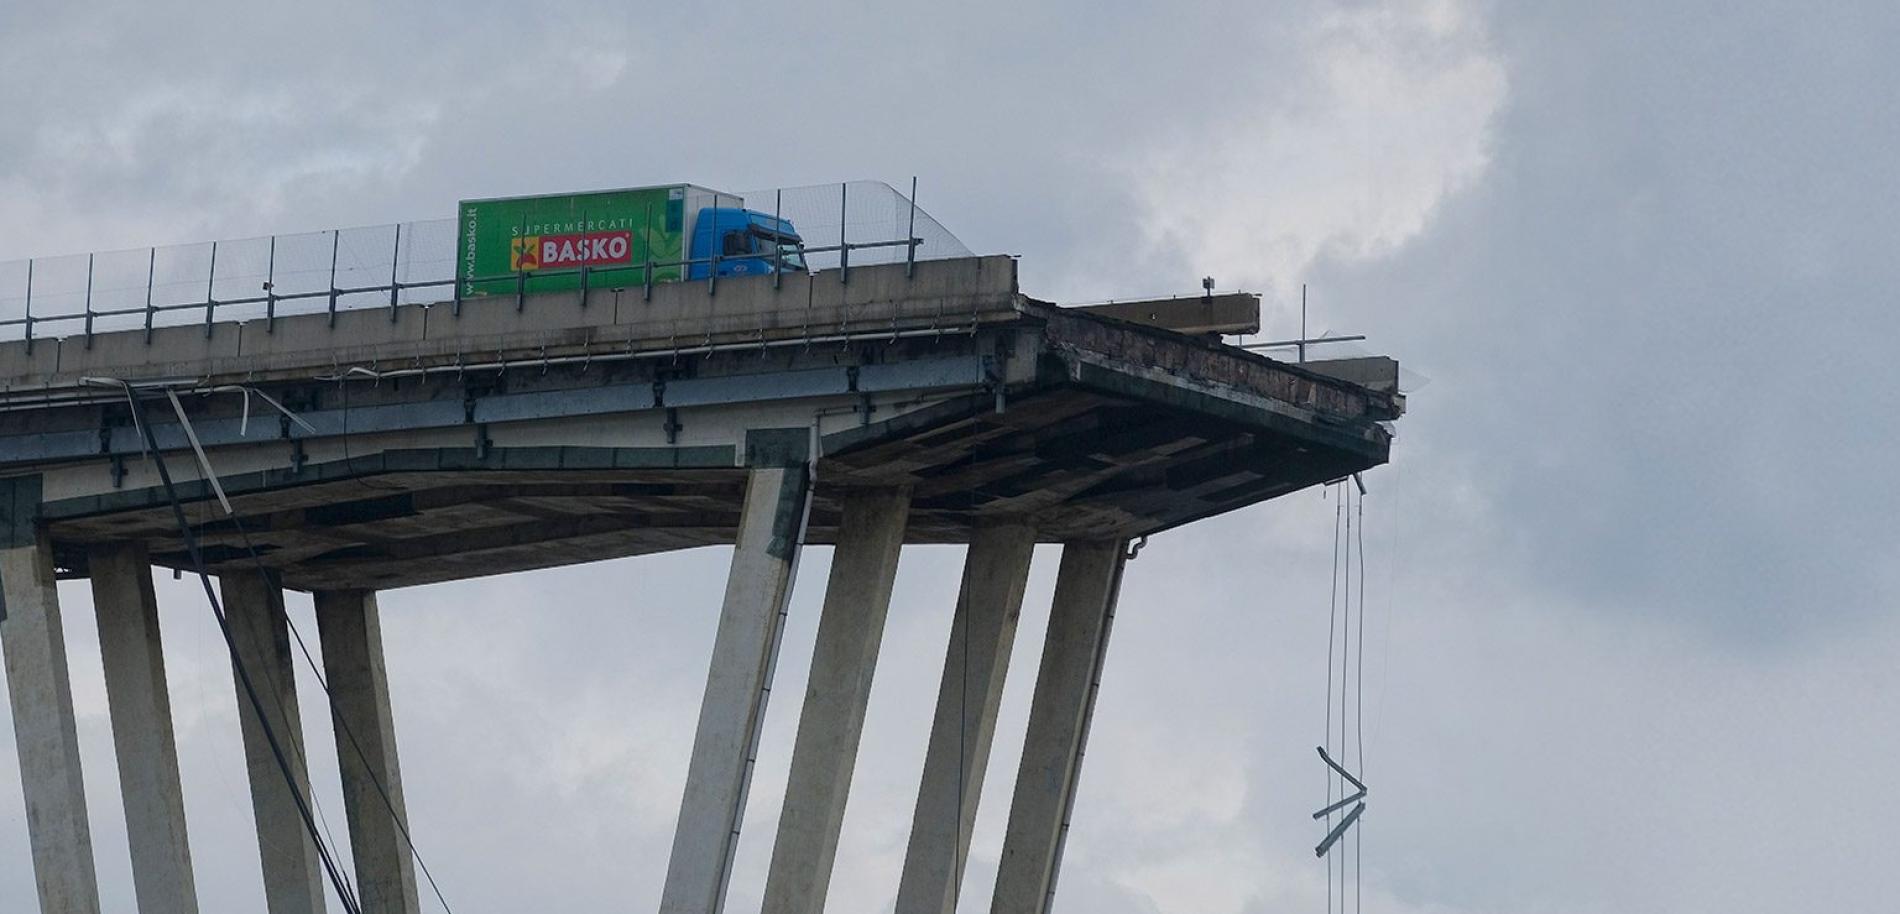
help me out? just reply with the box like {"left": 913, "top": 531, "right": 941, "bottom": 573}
{"left": 0, "top": 258, "right": 1402, "bottom": 589}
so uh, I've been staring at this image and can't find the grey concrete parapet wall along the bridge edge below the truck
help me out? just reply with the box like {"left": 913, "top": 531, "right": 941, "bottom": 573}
{"left": 0, "top": 257, "right": 1020, "bottom": 391}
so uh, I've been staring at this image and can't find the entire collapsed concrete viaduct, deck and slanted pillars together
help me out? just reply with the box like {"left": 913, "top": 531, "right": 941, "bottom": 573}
{"left": 0, "top": 257, "right": 1402, "bottom": 914}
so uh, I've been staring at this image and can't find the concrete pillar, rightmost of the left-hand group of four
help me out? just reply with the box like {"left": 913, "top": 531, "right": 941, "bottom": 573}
{"left": 315, "top": 591, "right": 422, "bottom": 914}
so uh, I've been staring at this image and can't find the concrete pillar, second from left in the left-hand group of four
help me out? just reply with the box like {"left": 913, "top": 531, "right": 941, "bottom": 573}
{"left": 87, "top": 543, "right": 198, "bottom": 914}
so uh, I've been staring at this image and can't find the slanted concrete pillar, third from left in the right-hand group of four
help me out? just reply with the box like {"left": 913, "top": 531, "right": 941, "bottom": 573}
{"left": 897, "top": 524, "right": 1036, "bottom": 914}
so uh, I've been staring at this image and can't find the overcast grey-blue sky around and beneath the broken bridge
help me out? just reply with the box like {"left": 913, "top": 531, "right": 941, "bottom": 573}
{"left": 0, "top": 0, "right": 1900, "bottom": 914}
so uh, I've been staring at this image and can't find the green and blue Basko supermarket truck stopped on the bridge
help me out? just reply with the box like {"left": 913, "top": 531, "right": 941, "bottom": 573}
{"left": 456, "top": 184, "right": 806, "bottom": 296}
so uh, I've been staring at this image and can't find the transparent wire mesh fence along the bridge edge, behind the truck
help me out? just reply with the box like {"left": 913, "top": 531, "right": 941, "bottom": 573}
{"left": 0, "top": 181, "right": 971, "bottom": 342}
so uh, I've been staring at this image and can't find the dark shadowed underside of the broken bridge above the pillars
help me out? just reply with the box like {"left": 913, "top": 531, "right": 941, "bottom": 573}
{"left": 48, "top": 386, "right": 1378, "bottom": 591}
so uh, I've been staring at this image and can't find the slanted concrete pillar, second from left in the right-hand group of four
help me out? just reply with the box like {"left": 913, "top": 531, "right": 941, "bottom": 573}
{"left": 764, "top": 490, "right": 910, "bottom": 914}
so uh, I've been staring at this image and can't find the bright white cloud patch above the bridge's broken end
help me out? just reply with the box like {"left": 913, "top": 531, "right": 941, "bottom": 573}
{"left": 1123, "top": 0, "right": 1507, "bottom": 300}
